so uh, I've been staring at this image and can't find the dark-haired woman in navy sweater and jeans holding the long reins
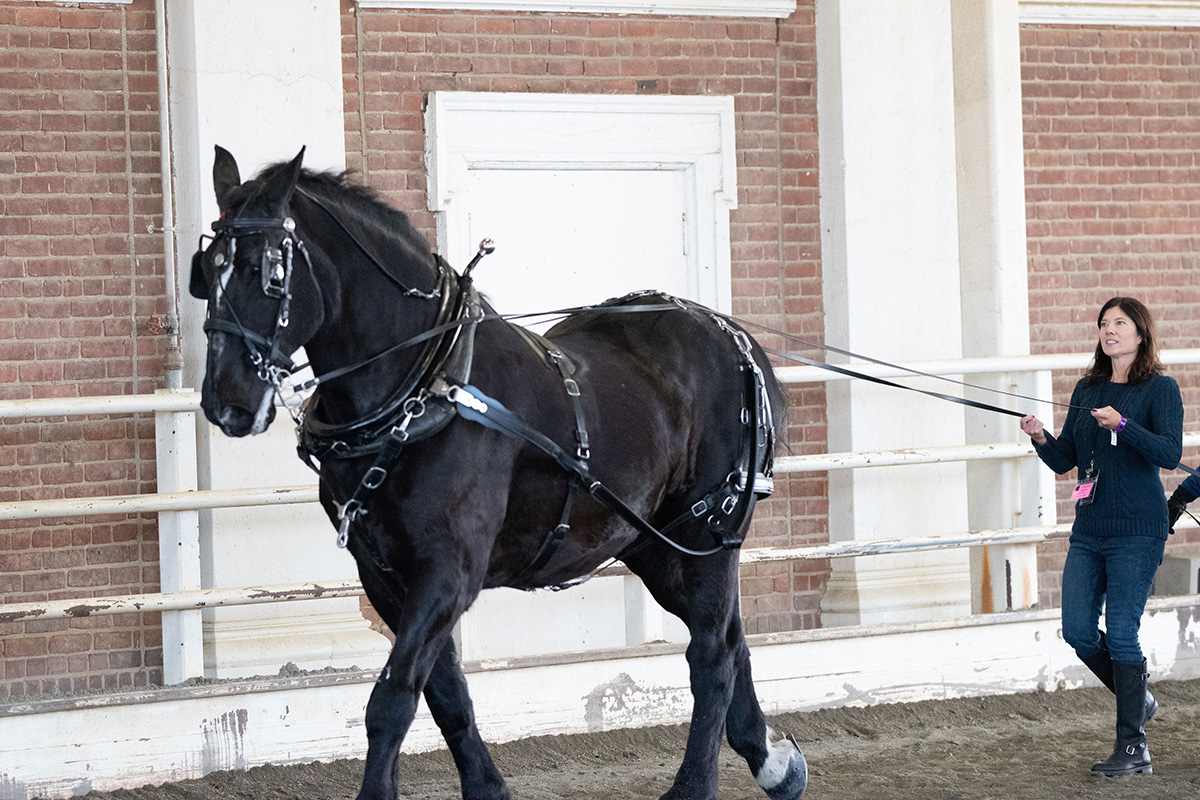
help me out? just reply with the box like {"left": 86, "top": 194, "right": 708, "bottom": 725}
{"left": 1021, "top": 297, "right": 1183, "bottom": 777}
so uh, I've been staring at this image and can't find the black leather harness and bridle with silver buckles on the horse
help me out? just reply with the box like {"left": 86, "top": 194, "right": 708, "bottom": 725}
{"left": 190, "top": 200, "right": 774, "bottom": 578}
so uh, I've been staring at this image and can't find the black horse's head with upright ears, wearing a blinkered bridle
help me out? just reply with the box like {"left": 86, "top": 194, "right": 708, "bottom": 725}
{"left": 190, "top": 146, "right": 325, "bottom": 437}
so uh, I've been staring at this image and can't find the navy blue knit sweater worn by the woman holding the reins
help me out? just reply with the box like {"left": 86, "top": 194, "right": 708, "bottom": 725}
{"left": 1033, "top": 375, "right": 1183, "bottom": 539}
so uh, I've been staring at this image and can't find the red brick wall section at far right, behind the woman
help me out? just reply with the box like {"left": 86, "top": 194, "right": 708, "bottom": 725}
{"left": 1021, "top": 26, "right": 1200, "bottom": 606}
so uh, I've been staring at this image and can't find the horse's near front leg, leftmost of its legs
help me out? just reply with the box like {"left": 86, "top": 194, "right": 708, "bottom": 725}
{"left": 358, "top": 563, "right": 469, "bottom": 800}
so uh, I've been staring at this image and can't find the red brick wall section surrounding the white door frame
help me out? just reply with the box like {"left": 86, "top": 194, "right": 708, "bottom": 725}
{"left": 342, "top": 1, "right": 828, "bottom": 632}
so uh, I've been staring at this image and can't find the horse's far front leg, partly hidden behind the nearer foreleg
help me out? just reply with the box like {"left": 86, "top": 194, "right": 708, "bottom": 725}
{"left": 425, "top": 640, "right": 509, "bottom": 800}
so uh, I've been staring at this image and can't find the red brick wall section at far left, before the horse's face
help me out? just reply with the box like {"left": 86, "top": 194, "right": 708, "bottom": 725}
{"left": 0, "top": 0, "right": 164, "bottom": 698}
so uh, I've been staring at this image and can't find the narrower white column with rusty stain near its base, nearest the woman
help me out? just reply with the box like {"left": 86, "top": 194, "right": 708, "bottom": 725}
{"left": 950, "top": 0, "right": 1054, "bottom": 613}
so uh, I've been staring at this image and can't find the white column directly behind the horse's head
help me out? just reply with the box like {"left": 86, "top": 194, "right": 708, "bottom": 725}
{"left": 167, "top": 0, "right": 388, "bottom": 678}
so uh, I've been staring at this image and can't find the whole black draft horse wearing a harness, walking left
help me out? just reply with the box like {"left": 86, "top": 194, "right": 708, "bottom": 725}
{"left": 191, "top": 148, "right": 808, "bottom": 800}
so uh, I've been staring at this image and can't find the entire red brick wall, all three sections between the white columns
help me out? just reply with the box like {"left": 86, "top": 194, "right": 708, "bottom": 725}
{"left": 9, "top": 0, "right": 1200, "bottom": 698}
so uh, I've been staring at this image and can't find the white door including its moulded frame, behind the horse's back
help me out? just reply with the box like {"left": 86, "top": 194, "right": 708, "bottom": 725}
{"left": 426, "top": 92, "right": 737, "bottom": 660}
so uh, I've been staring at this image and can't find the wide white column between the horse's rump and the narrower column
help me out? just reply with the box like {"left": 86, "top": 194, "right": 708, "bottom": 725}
{"left": 816, "top": 0, "right": 971, "bottom": 626}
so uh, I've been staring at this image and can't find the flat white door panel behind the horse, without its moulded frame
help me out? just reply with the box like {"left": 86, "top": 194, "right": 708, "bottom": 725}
{"left": 457, "top": 169, "right": 688, "bottom": 658}
